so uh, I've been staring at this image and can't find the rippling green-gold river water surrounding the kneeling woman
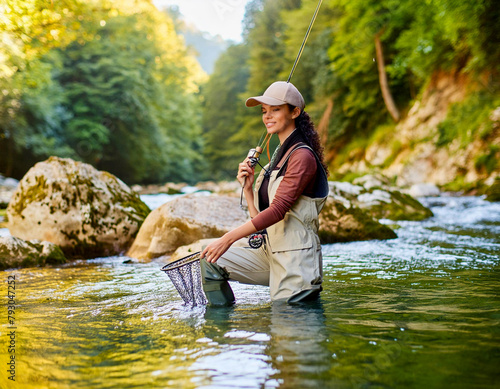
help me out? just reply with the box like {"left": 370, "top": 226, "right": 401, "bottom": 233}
{"left": 0, "top": 196, "right": 500, "bottom": 389}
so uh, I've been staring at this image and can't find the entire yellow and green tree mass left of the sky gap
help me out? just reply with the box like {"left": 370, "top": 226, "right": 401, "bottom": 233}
{"left": 0, "top": 0, "right": 203, "bottom": 183}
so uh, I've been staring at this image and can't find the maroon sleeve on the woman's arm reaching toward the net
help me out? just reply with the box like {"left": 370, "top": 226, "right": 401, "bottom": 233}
{"left": 252, "top": 148, "right": 318, "bottom": 231}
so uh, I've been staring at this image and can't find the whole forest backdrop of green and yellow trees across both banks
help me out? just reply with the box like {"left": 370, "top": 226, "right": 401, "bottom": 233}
{"left": 0, "top": 0, "right": 500, "bottom": 184}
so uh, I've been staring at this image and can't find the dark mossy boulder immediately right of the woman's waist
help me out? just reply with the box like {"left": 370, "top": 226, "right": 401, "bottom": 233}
{"left": 319, "top": 197, "right": 397, "bottom": 244}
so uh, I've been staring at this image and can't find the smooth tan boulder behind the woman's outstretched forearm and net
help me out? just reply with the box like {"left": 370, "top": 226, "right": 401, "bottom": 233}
{"left": 127, "top": 195, "right": 248, "bottom": 259}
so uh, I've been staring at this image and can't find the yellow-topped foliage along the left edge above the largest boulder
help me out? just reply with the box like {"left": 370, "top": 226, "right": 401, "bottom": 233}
{"left": 0, "top": 0, "right": 90, "bottom": 176}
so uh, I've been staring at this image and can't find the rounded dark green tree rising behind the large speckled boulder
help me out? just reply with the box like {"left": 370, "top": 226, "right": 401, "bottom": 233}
{"left": 54, "top": 11, "right": 203, "bottom": 182}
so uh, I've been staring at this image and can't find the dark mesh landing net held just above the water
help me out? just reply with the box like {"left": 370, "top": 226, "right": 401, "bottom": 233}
{"left": 161, "top": 252, "right": 207, "bottom": 306}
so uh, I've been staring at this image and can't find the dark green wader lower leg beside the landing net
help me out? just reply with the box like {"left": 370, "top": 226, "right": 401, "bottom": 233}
{"left": 200, "top": 259, "right": 234, "bottom": 307}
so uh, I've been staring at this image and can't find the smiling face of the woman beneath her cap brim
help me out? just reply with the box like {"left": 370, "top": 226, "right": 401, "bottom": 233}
{"left": 262, "top": 104, "right": 300, "bottom": 143}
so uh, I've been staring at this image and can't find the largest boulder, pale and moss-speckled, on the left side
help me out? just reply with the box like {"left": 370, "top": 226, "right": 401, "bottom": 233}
{"left": 7, "top": 157, "right": 150, "bottom": 258}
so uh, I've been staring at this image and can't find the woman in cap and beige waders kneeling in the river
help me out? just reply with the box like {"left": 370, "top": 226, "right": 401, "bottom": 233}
{"left": 201, "top": 81, "right": 328, "bottom": 305}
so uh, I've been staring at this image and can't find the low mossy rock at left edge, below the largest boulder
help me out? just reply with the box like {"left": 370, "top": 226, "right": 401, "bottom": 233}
{"left": 0, "top": 236, "right": 66, "bottom": 270}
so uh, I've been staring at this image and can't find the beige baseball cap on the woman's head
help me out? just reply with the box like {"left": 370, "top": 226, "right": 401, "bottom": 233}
{"left": 245, "top": 81, "right": 306, "bottom": 111}
